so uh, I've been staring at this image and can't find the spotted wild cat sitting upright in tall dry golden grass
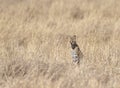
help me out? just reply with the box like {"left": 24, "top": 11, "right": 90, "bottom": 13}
{"left": 70, "top": 35, "right": 83, "bottom": 64}
